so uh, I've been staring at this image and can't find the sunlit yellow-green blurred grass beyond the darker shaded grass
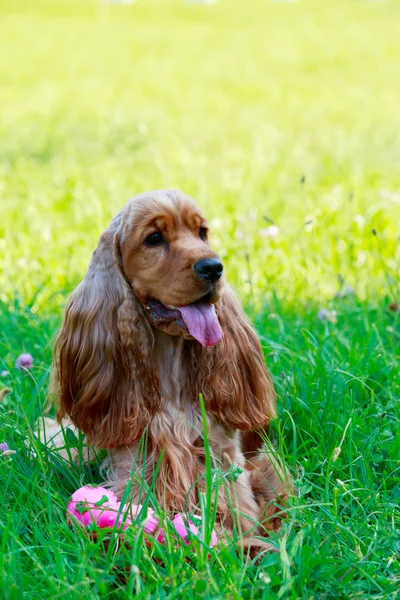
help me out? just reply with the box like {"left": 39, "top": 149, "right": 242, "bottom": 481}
{"left": 0, "top": 0, "right": 400, "bottom": 311}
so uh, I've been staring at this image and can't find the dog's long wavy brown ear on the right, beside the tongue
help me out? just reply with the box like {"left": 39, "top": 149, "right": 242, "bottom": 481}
{"left": 189, "top": 285, "right": 275, "bottom": 434}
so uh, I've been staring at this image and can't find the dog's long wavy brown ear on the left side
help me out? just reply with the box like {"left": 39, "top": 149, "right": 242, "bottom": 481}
{"left": 53, "top": 214, "right": 159, "bottom": 448}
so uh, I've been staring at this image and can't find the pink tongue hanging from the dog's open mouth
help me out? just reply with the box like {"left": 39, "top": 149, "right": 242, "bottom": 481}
{"left": 178, "top": 302, "right": 222, "bottom": 346}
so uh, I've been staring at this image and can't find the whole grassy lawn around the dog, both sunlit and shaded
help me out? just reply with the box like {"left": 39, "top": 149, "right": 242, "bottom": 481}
{"left": 0, "top": 0, "right": 400, "bottom": 600}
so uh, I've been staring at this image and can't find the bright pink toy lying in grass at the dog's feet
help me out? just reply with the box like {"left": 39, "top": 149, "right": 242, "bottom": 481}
{"left": 67, "top": 485, "right": 218, "bottom": 548}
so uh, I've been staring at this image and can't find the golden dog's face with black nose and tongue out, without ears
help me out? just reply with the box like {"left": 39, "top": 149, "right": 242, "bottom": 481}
{"left": 120, "top": 193, "right": 223, "bottom": 346}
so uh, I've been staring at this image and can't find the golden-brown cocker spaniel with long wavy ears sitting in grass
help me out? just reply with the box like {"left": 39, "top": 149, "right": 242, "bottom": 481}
{"left": 53, "top": 191, "right": 291, "bottom": 547}
